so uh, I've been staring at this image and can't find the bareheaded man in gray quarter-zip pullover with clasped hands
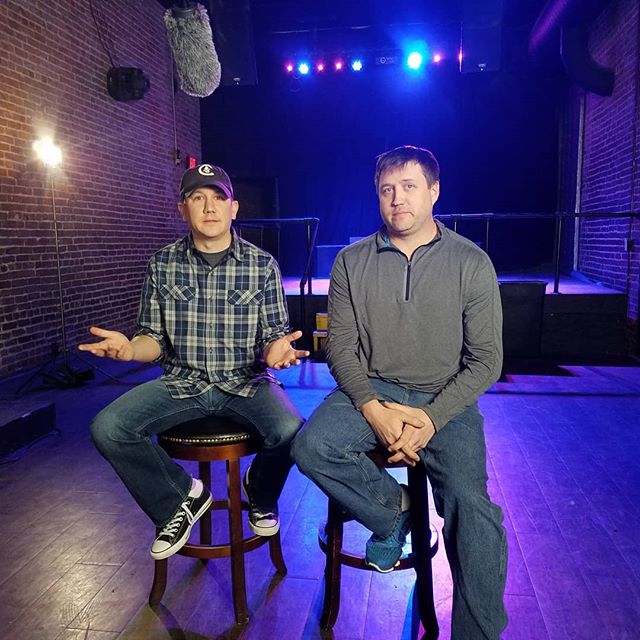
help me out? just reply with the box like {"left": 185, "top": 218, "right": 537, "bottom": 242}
{"left": 292, "top": 146, "right": 507, "bottom": 640}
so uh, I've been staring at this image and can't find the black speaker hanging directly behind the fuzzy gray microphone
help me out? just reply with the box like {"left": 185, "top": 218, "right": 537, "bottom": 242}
{"left": 209, "top": 0, "right": 258, "bottom": 86}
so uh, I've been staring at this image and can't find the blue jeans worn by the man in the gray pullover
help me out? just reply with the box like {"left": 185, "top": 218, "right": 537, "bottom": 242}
{"left": 292, "top": 379, "right": 507, "bottom": 640}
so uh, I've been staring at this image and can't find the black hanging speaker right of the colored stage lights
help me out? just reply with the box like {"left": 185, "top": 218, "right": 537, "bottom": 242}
{"left": 460, "top": 0, "right": 503, "bottom": 73}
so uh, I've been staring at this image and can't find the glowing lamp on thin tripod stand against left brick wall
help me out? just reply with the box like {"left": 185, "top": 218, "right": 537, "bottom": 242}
{"left": 16, "top": 139, "right": 120, "bottom": 396}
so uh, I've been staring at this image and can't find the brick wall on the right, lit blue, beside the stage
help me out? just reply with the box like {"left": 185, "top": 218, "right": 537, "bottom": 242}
{"left": 578, "top": 0, "right": 640, "bottom": 349}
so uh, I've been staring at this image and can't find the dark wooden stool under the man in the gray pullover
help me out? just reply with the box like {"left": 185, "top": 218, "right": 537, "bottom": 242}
{"left": 318, "top": 450, "right": 439, "bottom": 640}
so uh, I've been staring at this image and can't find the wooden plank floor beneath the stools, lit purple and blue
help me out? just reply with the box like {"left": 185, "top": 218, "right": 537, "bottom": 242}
{"left": 0, "top": 363, "right": 640, "bottom": 640}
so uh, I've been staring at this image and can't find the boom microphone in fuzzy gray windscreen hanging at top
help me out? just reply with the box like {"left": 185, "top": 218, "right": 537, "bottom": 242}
{"left": 164, "top": 2, "right": 220, "bottom": 98}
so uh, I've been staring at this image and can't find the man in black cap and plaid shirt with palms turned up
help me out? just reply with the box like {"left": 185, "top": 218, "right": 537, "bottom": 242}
{"left": 79, "top": 164, "right": 309, "bottom": 560}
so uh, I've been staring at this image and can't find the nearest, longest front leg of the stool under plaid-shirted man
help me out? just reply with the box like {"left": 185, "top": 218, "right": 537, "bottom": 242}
{"left": 227, "top": 459, "right": 249, "bottom": 624}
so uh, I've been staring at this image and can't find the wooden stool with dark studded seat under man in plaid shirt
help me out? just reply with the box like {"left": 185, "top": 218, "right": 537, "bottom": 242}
{"left": 149, "top": 416, "right": 287, "bottom": 623}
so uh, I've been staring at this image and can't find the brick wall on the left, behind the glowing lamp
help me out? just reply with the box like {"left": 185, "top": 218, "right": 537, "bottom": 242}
{"left": 0, "top": 0, "right": 200, "bottom": 376}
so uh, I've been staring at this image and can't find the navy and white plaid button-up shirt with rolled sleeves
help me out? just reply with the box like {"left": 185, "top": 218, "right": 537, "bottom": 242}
{"left": 135, "top": 233, "right": 289, "bottom": 398}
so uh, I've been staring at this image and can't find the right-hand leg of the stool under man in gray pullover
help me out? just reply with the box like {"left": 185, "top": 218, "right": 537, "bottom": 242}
{"left": 407, "top": 464, "right": 439, "bottom": 640}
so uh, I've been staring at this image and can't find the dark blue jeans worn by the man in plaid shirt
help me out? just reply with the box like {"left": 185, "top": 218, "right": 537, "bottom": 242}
{"left": 91, "top": 379, "right": 303, "bottom": 527}
